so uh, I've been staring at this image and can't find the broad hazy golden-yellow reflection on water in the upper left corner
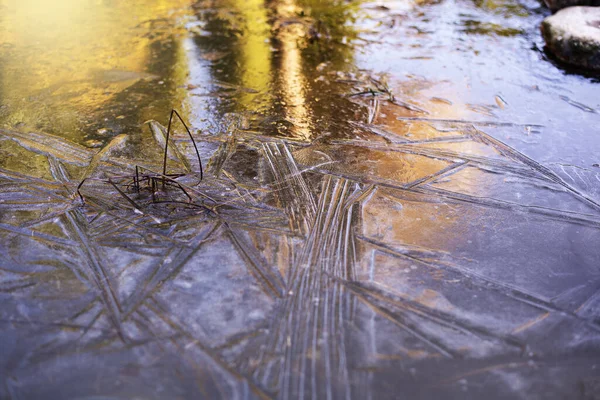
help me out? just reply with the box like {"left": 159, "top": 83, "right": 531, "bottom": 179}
{"left": 0, "top": 0, "right": 190, "bottom": 136}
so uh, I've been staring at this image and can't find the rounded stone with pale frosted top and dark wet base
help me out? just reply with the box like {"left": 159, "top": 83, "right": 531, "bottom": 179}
{"left": 542, "top": 7, "right": 600, "bottom": 70}
